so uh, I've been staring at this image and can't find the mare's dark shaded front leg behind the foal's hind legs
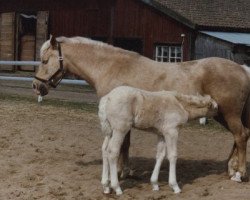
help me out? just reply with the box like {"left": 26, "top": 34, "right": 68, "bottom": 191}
{"left": 118, "top": 131, "right": 131, "bottom": 178}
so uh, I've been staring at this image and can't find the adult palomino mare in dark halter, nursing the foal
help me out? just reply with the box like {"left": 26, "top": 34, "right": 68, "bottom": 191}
{"left": 33, "top": 37, "right": 250, "bottom": 182}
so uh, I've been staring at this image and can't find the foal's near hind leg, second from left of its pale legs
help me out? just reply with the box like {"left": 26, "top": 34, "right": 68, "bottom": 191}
{"left": 108, "top": 130, "right": 125, "bottom": 195}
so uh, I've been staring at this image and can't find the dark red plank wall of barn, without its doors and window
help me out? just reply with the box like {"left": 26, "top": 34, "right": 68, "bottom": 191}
{"left": 0, "top": 0, "right": 192, "bottom": 63}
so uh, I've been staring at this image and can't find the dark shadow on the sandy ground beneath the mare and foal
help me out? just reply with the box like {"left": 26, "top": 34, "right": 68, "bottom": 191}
{"left": 76, "top": 157, "right": 250, "bottom": 189}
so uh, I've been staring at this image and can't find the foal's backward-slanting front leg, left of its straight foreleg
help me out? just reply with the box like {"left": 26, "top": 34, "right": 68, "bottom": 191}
{"left": 150, "top": 136, "right": 166, "bottom": 191}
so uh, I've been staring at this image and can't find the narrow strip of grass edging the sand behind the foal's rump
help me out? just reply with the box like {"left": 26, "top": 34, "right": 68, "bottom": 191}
{"left": 0, "top": 93, "right": 98, "bottom": 113}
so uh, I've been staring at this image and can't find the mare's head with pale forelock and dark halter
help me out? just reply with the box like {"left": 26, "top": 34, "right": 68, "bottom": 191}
{"left": 32, "top": 36, "right": 66, "bottom": 96}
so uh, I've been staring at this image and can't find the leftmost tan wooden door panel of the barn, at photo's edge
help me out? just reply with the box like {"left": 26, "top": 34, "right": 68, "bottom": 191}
{"left": 0, "top": 13, "right": 15, "bottom": 70}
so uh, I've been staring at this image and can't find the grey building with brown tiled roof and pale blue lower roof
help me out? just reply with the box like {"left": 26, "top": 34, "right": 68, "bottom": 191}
{"left": 155, "top": 0, "right": 250, "bottom": 66}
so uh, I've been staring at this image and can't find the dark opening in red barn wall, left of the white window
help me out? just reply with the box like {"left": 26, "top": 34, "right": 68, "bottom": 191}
{"left": 114, "top": 38, "right": 143, "bottom": 54}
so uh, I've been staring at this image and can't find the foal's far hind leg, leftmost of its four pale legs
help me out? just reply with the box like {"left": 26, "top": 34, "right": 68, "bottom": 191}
{"left": 101, "top": 136, "right": 110, "bottom": 194}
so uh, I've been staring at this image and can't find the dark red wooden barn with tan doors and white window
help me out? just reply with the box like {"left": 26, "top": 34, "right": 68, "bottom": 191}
{"left": 0, "top": 0, "right": 195, "bottom": 70}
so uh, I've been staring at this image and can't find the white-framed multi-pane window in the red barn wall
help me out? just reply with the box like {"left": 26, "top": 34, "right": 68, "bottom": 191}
{"left": 155, "top": 45, "right": 183, "bottom": 62}
